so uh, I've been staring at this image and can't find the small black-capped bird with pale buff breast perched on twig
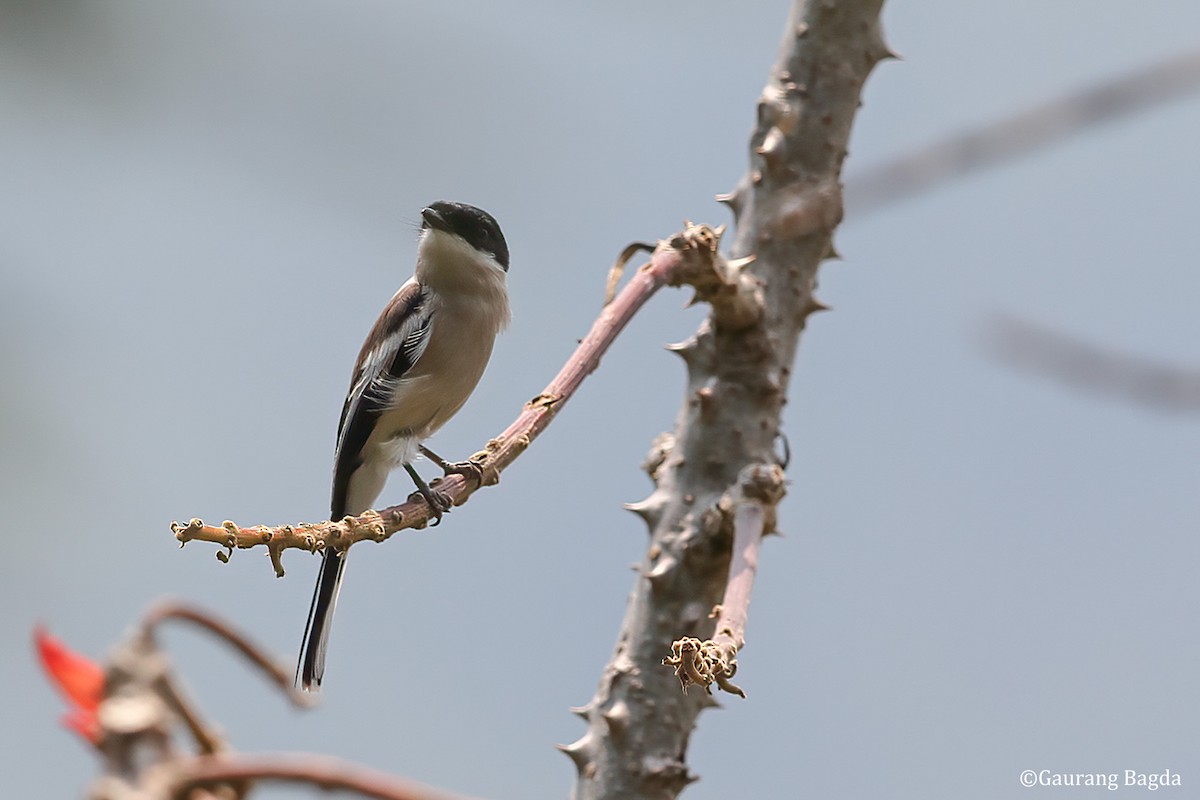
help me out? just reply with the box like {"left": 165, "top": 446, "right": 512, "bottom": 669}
{"left": 295, "top": 200, "right": 511, "bottom": 692}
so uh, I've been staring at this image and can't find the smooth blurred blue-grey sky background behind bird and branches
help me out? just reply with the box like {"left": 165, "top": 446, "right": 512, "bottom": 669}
{"left": 0, "top": 0, "right": 1200, "bottom": 799}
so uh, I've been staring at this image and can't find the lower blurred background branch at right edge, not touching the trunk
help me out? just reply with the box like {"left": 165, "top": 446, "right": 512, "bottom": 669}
{"left": 982, "top": 315, "right": 1200, "bottom": 413}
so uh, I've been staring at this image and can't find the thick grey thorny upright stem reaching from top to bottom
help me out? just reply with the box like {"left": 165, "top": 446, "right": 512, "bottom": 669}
{"left": 564, "top": 0, "right": 889, "bottom": 800}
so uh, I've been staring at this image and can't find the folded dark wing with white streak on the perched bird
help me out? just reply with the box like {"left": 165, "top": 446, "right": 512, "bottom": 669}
{"left": 331, "top": 278, "right": 433, "bottom": 519}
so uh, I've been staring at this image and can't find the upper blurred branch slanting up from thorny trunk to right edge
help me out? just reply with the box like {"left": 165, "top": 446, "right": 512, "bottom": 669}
{"left": 846, "top": 49, "right": 1200, "bottom": 215}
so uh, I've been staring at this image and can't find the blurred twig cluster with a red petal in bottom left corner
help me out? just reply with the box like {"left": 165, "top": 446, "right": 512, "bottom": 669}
{"left": 35, "top": 603, "right": 472, "bottom": 800}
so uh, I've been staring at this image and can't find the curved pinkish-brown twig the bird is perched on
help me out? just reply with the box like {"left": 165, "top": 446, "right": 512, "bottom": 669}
{"left": 172, "top": 223, "right": 757, "bottom": 577}
